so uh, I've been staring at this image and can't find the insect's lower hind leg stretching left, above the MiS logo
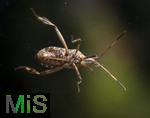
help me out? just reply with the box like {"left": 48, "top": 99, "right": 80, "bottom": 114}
{"left": 15, "top": 66, "right": 63, "bottom": 75}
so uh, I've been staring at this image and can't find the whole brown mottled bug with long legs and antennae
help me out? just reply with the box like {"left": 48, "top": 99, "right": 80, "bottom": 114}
{"left": 15, "top": 8, "right": 126, "bottom": 92}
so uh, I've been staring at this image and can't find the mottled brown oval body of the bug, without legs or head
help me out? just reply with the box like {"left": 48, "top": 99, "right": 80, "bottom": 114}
{"left": 37, "top": 47, "right": 85, "bottom": 67}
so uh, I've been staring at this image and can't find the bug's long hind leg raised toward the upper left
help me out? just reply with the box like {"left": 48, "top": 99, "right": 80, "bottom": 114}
{"left": 31, "top": 8, "right": 68, "bottom": 54}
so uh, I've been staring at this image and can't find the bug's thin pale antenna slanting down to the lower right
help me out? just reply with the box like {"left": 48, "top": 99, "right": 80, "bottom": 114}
{"left": 96, "top": 61, "right": 126, "bottom": 91}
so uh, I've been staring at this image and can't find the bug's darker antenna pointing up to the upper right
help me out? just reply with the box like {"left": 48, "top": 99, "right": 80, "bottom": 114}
{"left": 99, "top": 30, "right": 127, "bottom": 58}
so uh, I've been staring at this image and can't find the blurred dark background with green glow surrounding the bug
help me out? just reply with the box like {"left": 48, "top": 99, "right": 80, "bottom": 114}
{"left": 0, "top": 0, "right": 150, "bottom": 118}
